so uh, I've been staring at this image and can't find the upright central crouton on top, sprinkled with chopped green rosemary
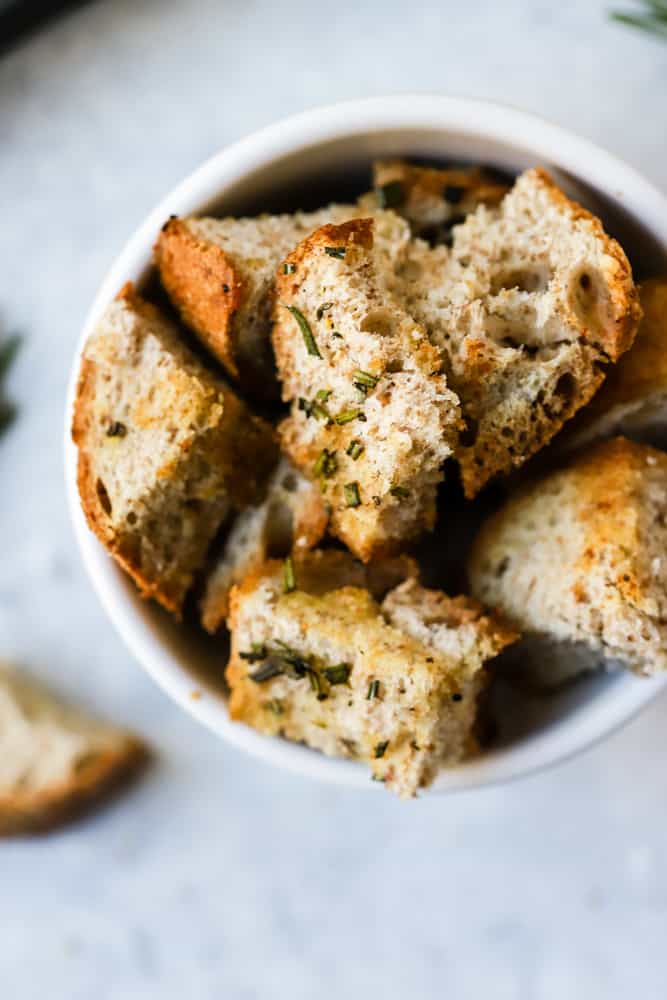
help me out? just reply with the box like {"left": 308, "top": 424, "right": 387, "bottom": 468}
{"left": 273, "top": 217, "right": 459, "bottom": 561}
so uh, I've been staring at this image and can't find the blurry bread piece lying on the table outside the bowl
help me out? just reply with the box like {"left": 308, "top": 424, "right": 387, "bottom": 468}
{"left": 0, "top": 664, "right": 148, "bottom": 836}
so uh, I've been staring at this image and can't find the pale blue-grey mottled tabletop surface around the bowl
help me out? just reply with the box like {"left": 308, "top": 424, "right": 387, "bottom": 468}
{"left": 0, "top": 0, "right": 667, "bottom": 1000}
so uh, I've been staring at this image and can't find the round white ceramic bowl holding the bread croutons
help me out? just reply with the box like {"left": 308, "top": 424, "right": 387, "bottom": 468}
{"left": 65, "top": 96, "right": 667, "bottom": 791}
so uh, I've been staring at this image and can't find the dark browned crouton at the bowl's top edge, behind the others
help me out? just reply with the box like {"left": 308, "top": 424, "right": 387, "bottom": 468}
{"left": 374, "top": 160, "right": 508, "bottom": 243}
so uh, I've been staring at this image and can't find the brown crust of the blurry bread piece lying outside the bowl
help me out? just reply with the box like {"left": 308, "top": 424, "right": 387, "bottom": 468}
{"left": 0, "top": 735, "right": 150, "bottom": 837}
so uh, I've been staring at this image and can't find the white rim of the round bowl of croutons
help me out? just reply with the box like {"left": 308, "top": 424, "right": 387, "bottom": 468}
{"left": 64, "top": 94, "right": 667, "bottom": 793}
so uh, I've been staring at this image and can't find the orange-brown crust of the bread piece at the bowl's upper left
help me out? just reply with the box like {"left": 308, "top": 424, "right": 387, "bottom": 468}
{"left": 153, "top": 218, "right": 244, "bottom": 378}
